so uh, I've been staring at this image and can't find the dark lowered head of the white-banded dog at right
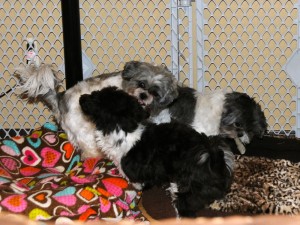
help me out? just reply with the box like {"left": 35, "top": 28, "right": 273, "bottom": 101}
{"left": 220, "top": 92, "right": 267, "bottom": 144}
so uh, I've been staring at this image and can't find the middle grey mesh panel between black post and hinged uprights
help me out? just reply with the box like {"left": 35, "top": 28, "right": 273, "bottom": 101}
{"left": 80, "top": 0, "right": 172, "bottom": 75}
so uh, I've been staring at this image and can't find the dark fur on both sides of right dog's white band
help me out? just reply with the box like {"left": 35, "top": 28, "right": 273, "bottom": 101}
{"left": 169, "top": 86, "right": 268, "bottom": 144}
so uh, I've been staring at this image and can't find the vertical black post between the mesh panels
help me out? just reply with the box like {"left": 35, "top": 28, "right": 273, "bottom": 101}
{"left": 61, "top": 0, "right": 83, "bottom": 89}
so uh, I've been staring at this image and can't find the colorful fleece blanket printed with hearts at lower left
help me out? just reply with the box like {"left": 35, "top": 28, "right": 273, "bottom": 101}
{"left": 0, "top": 123, "right": 145, "bottom": 221}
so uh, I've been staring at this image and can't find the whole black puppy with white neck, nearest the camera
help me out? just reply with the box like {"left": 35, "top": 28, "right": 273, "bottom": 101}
{"left": 79, "top": 87, "right": 234, "bottom": 217}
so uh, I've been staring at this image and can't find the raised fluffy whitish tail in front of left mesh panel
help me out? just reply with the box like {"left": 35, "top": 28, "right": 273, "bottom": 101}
{"left": 15, "top": 64, "right": 62, "bottom": 121}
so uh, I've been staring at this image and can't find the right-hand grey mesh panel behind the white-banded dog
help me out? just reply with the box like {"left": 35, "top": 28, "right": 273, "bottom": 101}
{"left": 198, "top": 0, "right": 298, "bottom": 135}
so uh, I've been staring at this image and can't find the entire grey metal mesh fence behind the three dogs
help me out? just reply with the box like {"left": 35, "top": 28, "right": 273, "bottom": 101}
{"left": 0, "top": 0, "right": 300, "bottom": 136}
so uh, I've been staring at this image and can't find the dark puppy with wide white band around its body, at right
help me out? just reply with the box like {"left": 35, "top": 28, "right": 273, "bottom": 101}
{"left": 152, "top": 86, "right": 267, "bottom": 154}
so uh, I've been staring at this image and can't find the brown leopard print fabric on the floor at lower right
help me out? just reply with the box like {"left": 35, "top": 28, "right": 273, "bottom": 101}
{"left": 210, "top": 156, "right": 300, "bottom": 215}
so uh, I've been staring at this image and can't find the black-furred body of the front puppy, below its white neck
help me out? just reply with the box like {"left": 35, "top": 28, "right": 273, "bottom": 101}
{"left": 121, "top": 122, "right": 232, "bottom": 217}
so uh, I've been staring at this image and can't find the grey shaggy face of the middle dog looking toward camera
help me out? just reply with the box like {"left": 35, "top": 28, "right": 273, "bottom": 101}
{"left": 122, "top": 61, "right": 178, "bottom": 115}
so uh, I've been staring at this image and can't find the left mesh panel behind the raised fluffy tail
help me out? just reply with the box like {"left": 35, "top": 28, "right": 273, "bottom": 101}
{"left": 0, "top": 0, "right": 64, "bottom": 137}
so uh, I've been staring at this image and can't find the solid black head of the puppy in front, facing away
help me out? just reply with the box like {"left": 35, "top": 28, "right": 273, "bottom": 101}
{"left": 79, "top": 87, "right": 149, "bottom": 134}
